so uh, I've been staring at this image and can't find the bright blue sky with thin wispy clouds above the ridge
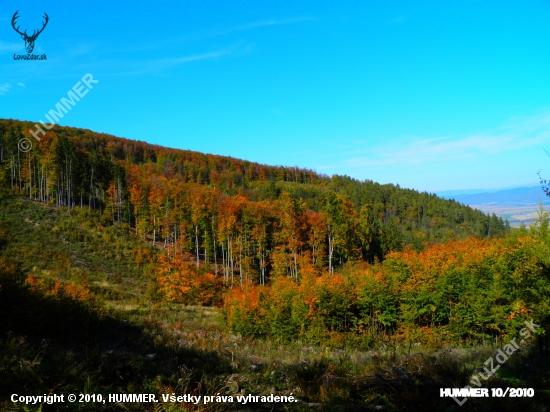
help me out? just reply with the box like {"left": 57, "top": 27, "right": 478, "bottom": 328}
{"left": 0, "top": 0, "right": 550, "bottom": 191}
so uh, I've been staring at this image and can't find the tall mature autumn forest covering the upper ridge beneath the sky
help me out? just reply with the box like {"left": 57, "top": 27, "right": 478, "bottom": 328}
{"left": 0, "top": 120, "right": 508, "bottom": 283}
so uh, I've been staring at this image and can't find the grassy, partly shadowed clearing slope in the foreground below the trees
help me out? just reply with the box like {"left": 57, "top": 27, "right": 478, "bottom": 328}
{"left": 0, "top": 194, "right": 548, "bottom": 411}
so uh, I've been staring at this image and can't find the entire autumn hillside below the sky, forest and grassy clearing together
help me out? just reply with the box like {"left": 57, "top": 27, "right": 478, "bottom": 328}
{"left": 0, "top": 120, "right": 550, "bottom": 410}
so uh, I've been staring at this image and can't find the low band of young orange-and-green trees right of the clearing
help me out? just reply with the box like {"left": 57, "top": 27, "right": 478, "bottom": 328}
{"left": 225, "top": 237, "right": 550, "bottom": 348}
